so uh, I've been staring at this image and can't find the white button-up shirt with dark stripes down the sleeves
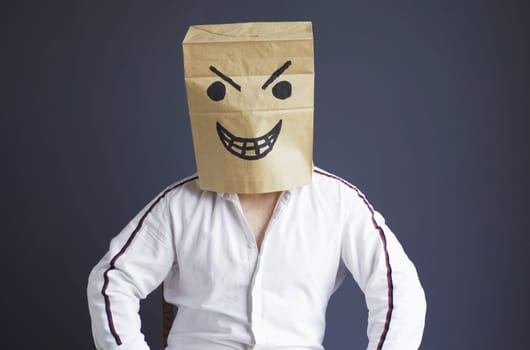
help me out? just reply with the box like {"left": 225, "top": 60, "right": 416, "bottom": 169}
{"left": 88, "top": 168, "right": 426, "bottom": 350}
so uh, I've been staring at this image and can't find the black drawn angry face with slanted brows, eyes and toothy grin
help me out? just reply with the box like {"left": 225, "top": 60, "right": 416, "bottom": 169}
{"left": 206, "top": 61, "right": 292, "bottom": 160}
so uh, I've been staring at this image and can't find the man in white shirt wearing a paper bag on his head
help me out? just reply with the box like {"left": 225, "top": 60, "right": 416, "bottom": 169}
{"left": 88, "top": 22, "right": 425, "bottom": 350}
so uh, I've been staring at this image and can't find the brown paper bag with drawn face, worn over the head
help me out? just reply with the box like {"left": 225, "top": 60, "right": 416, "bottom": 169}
{"left": 183, "top": 22, "right": 314, "bottom": 193}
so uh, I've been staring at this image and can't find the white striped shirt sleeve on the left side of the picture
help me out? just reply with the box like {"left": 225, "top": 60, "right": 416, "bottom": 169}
{"left": 87, "top": 191, "right": 176, "bottom": 350}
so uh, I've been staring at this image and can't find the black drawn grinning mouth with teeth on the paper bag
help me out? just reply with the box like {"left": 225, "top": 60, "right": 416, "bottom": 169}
{"left": 216, "top": 120, "right": 282, "bottom": 160}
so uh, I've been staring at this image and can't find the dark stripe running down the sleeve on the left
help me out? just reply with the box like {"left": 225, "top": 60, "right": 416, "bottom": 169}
{"left": 101, "top": 176, "right": 197, "bottom": 345}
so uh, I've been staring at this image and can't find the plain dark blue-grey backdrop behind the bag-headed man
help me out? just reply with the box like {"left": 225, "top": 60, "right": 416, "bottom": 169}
{"left": 0, "top": 0, "right": 530, "bottom": 350}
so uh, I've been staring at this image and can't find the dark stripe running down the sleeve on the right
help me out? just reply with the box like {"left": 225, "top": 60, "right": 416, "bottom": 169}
{"left": 314, "top": 169, "right": 394, "bottom": 350}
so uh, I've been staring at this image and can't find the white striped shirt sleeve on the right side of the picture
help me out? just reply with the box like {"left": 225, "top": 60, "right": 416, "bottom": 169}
{"left": 341, "top": 189, "right": 426, "bottom": 350}
